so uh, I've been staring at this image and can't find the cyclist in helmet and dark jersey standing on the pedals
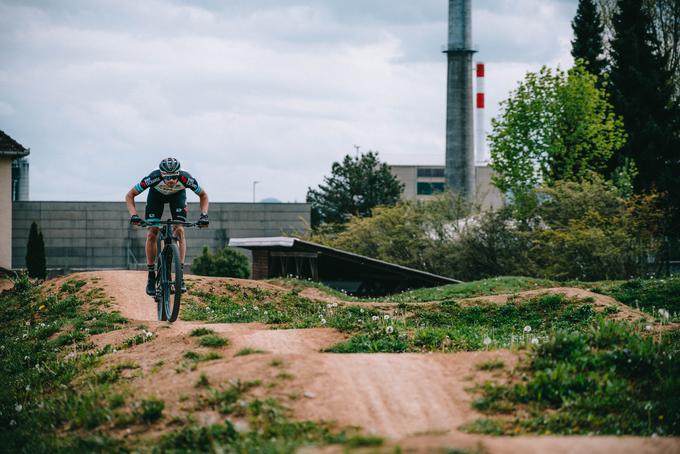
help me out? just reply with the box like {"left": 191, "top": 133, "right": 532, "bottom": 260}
{"left": 125, "top": 158, "right": 209, "bottom": 296}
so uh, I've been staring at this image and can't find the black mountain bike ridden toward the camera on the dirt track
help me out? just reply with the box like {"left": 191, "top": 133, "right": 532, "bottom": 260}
{"left": 141, "top": 219, "right": 197, "bottom": 322}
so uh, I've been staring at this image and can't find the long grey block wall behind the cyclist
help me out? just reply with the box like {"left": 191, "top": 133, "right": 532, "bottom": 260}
{"left": 12, "top": 201, "right": 310, "bottom": 269}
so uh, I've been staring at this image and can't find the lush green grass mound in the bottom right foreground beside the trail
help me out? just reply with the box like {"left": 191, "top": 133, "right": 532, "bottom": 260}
{"left": 466, "top": 321, "right": 680, "bottom": 436}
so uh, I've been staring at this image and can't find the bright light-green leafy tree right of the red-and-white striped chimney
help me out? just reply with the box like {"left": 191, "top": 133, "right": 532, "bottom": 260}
{"left": 489, "top": 64, "right": 625, "bottom": 197}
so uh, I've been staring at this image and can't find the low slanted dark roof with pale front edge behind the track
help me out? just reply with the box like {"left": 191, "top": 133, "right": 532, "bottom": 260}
{"left": 229, "top": 236, "right": 461, "bottom": 286}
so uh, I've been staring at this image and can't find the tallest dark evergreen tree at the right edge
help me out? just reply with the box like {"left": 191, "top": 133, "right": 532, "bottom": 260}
{"left": 609, "top": 0, "right": 680, "bottom": 208}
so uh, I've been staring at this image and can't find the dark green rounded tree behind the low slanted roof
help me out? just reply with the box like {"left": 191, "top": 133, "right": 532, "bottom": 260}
{"left": 307, "top": 151, "right": 404, "bottom": 226}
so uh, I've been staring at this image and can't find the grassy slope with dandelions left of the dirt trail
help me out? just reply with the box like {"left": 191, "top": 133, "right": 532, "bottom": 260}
{"left": 0, "top": 277, "right": 377, "bottom": 453}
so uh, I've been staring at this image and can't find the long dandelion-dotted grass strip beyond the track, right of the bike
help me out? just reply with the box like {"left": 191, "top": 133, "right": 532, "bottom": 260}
{"left": 184, "top": 286, "right": 595, "bottom": 353}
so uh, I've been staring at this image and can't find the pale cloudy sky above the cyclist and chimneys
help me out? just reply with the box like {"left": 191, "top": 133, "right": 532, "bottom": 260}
{"left": 0, "top": 0, "right": 577, "bottom": 202}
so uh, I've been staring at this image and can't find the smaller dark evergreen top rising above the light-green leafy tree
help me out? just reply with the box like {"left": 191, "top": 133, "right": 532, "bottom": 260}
{"left": 571, "top": 0, "right": 606, "bottom": 79}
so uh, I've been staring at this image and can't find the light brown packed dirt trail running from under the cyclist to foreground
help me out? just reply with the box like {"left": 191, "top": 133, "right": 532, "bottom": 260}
{"left": 78, "top": 271, "right": 680, "bottom": 454}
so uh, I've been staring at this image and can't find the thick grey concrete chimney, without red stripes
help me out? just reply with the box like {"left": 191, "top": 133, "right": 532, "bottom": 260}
{"left": 444, "top": 0, "right": 475, "bottom": 201}
